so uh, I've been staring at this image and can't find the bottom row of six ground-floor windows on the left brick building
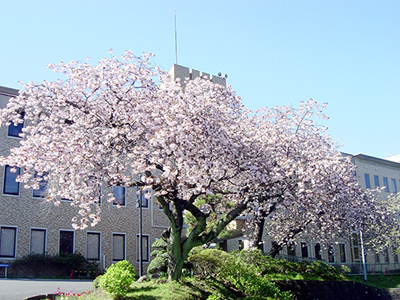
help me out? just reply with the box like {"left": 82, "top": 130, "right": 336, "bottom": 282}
{"left": 0, "top": 226, "right": 150, "bottom": 262}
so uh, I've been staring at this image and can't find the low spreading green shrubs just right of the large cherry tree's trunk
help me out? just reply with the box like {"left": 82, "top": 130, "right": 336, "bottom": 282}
{"left": 189, "top": 249, "right": 347, "bottom": 299}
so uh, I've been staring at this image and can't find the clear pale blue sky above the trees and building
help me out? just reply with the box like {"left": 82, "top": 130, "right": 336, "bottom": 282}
{"left": 0, "top": 0, "right": 400, "bottom": 158}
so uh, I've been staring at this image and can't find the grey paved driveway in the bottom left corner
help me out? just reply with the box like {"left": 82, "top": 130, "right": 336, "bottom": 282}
{"left": 0, "top": 278, "right": 92, "bottom": 300}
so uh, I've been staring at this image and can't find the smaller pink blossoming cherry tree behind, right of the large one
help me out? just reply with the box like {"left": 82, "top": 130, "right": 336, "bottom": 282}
{"left": 249, "top": 100, "right": 385, "bottom": 256}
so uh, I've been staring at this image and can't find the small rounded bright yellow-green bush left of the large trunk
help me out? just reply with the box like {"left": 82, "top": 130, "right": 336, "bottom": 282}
{"left": 98, "top": 260, "right": 136, "bottom": 300}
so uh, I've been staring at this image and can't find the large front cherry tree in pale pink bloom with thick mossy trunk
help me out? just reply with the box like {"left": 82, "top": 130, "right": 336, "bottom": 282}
{"left": 0, "top": 52, "right": 268, "bottom": 280}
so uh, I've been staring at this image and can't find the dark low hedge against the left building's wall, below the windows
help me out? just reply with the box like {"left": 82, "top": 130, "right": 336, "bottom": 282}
{"left": 9, "top": 253, "right": 100, "bottom": 278}
